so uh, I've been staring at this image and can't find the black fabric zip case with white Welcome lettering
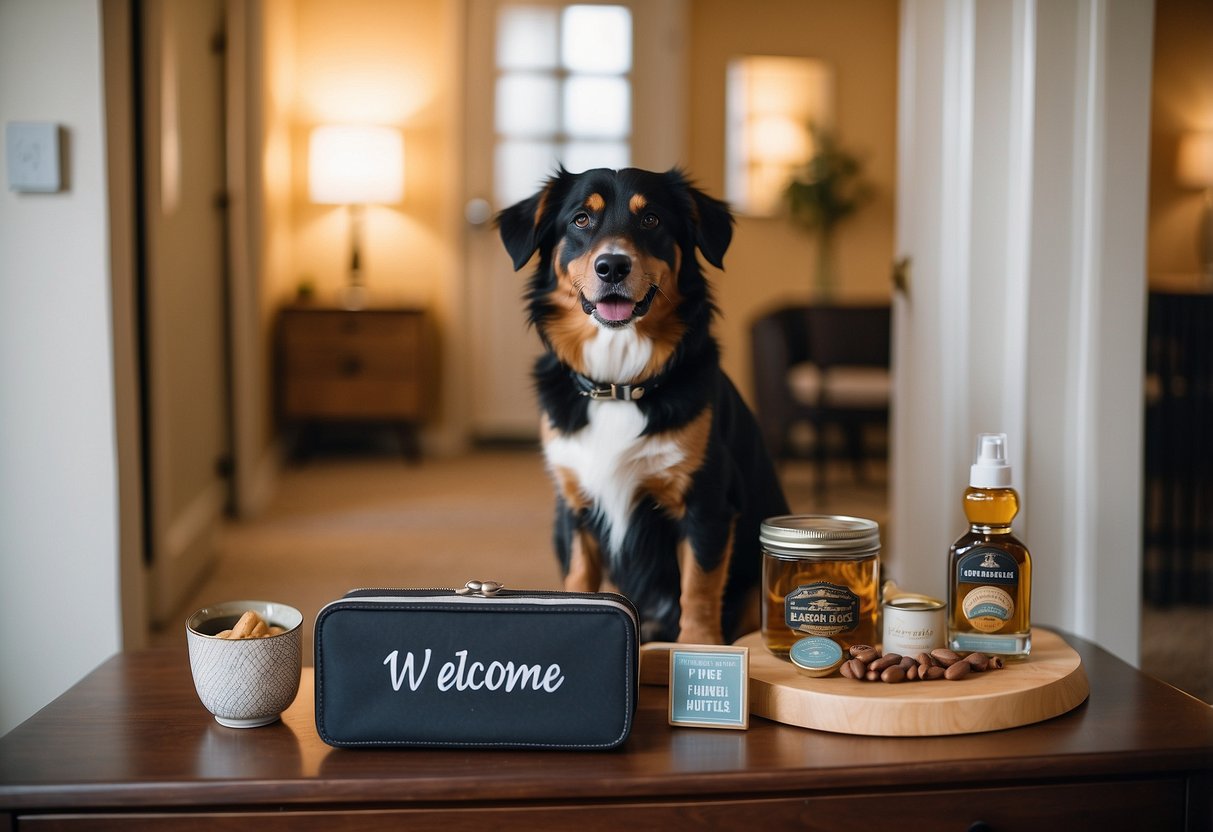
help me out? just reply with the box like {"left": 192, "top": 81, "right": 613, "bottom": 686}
{"left": 315, "top": 589, "right": 639, "bottom": 751}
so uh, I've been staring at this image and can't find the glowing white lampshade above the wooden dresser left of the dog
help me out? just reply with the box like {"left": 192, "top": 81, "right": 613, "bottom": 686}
{"left": 308, "top": 125, "right": 404, "bottom": 205}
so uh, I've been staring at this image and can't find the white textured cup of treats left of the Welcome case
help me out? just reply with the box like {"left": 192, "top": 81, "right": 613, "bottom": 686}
{"left": 186, "top": 600, "right": 303, "bottom": 728}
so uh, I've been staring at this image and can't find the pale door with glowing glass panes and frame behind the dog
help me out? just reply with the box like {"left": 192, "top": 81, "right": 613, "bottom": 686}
{"left": 465, "top": 0, "right": 685, "bottom": 440}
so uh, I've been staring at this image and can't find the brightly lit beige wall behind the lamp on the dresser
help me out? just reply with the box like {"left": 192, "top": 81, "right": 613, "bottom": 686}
{"left": 292, "top": 0, "right": 461, "bottom": 312}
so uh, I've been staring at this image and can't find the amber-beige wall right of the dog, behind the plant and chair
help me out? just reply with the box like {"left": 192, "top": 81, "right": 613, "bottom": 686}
{"left": 687, "top": 0, "right": 898, "bottom": 395}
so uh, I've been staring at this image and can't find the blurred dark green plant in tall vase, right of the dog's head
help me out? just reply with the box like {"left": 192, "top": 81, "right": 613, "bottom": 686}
{"left": 784, "top": 124, "right": 872, "bottom": 301}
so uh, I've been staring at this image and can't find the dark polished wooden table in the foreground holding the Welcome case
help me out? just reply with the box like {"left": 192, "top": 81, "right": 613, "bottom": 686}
{"left": 0, "top": 637, "right": 1213, "bottom": 832}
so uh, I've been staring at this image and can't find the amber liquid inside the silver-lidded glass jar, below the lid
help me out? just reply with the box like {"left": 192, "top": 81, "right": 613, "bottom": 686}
{"left": 762, "top": 552, "right": 881, "bottom": 656}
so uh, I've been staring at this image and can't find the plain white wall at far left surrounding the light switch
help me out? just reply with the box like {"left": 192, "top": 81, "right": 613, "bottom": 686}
{"left": 0, "top": 0, "right": 121, "bottom": 734}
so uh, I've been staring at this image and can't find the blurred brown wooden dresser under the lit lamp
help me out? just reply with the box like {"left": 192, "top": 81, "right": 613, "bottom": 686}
{"left": 277, "top": 306, "right": 432, "bottom": 457}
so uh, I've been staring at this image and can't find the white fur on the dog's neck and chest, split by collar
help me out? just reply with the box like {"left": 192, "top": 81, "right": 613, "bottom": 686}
{"left": 543, "top": 327, "right": 685, "bottom": 553}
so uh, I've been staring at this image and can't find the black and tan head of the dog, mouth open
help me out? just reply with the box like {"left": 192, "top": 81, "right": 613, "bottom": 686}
{"left": 497, "top": 169, "right": 733, "bottom": 367}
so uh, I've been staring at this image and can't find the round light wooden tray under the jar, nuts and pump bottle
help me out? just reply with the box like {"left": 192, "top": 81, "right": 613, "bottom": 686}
{"left": 738, "top": 627, "right": 1090, "bottom": 736}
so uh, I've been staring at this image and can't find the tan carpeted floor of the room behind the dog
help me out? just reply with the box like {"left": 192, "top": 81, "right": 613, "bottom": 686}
{"left": 153, "top": 449, "right": 1213, "bottom": 702}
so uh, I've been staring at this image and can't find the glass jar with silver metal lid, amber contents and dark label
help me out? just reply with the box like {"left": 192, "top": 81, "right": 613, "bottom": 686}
{"left": 758, "top": 514, "right": 881, "bottom": 659}
